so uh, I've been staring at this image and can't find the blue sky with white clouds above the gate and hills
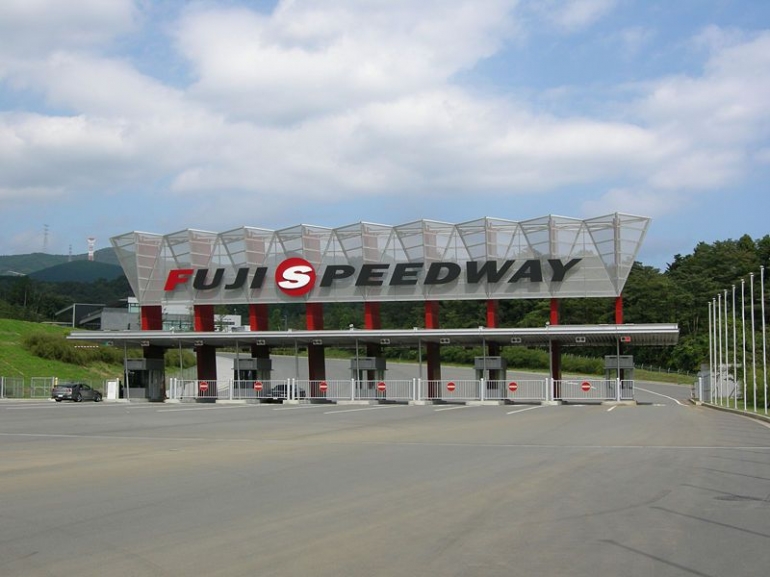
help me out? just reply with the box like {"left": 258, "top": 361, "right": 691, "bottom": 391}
{"left": 0, "top": 0, "right": 770, "bottom": 269}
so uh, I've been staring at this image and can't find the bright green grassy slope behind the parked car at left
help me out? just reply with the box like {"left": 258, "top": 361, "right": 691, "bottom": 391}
{"left": 0, "top": 319, "right": 122, "bottom": 381}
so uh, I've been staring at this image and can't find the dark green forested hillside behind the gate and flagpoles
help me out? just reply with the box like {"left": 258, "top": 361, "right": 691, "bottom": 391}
{"left": 0, "top": 235, "right": 770, "bottom": 372}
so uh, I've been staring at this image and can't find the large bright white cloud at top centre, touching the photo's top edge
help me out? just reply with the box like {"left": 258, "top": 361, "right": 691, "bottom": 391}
{"left": 177, "top": 0, "right": 515, "bottom": 123}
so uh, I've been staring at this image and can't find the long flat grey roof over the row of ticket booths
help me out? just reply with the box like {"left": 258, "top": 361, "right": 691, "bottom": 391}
{"left": 67, "top": 324, "right": 679, "bottom": 348}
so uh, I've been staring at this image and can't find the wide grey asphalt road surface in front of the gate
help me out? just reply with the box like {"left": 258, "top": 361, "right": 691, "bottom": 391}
{"left": 0, "top": 384, "right": 770, "bottom": 577}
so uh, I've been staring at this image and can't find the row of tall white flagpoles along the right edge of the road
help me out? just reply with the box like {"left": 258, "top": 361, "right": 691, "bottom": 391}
{"left": 702, "top": 266, "right": 768, "bottom": 415}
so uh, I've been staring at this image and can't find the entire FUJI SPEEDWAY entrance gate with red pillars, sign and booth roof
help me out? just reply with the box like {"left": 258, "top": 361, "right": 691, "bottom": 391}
{"left": 69, "top": 213, "right": 679, "bottom": 400}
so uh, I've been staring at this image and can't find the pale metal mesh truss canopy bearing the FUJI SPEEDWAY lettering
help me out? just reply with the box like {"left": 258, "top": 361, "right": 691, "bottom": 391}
{"left": 111, "top": 213, "right": 650, "bottom": 305}
